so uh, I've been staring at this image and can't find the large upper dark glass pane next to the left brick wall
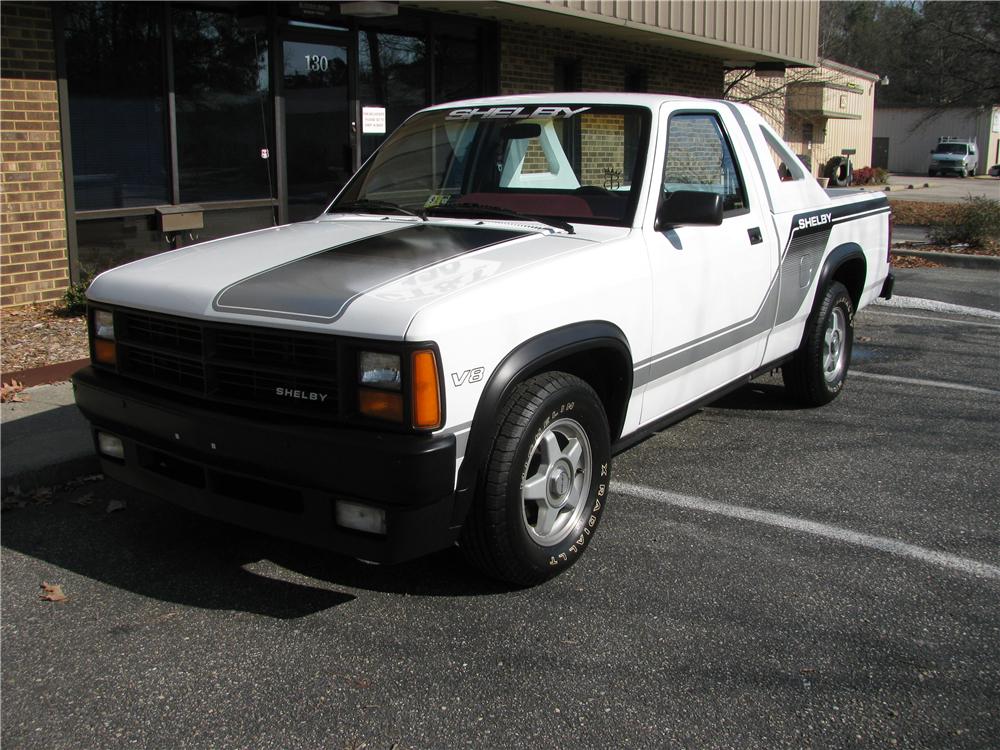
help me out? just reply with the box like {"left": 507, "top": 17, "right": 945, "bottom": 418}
{"left": 62, "top": 2, "right": 169, "bottom": 210}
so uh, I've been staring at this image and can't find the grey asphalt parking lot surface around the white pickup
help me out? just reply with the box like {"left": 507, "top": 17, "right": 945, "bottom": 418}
{"left": 2, "top": 290, "right": 1000, "bottom": 750}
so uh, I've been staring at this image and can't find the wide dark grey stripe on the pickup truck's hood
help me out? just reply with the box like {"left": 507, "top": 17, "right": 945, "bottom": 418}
{"left": 212, "top": 224, "right": 530, "bottom": 323}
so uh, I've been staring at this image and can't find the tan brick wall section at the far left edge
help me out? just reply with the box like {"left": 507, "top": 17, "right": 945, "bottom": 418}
{"left": 0, "top": 0, "right": 69, "bottom": 307}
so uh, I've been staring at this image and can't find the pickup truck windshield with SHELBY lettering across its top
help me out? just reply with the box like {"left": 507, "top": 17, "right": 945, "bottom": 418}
{"left": 329, "top": 104, "right": 649, "bottom": 225}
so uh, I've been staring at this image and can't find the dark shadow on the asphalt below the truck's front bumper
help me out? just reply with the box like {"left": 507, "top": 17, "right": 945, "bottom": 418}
{"left": 0, "top": 480, "right": 510, "bottom": 619}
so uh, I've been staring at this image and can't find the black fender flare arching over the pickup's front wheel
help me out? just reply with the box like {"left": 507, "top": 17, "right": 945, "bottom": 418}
{"left": 452, "top": 320, "right": 632, "bottom": 524}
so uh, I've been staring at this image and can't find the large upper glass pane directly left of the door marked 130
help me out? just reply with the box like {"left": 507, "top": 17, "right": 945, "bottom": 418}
{"left": 173, "top": 7, "right": 274, "bottom": 209}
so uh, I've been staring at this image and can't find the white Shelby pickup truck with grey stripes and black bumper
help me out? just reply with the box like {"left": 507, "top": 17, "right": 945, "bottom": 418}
{"left": 74, "top": 94, "right": 892, "bottom": 585}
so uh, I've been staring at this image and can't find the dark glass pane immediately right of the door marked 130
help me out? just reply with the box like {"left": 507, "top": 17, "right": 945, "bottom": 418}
{"left": 358, "top": 31, "right": 428, "bottom": 160}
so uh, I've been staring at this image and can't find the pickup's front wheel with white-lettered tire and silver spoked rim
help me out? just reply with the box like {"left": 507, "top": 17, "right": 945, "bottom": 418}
{"left": 460, "top": 372, "right": 611, "bottom": 586}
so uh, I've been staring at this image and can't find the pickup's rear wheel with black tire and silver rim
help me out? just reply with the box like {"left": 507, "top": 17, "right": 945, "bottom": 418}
{"left": 781, "top": 281, "right": 854, "bottom": 406}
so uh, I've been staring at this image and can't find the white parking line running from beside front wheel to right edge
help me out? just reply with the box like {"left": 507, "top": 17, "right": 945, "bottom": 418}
{"left": 611, "top": 482, "right": 1000, "bottom": 581}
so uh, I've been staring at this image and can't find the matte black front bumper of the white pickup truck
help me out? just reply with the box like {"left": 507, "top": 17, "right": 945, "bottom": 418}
{"left": 73, "top": 367, "right": 459, "bottom": 562}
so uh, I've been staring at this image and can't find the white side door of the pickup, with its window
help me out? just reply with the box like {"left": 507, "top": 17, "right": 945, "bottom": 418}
{"left": 642, "top": 111, "right": 777, "bottom": 423}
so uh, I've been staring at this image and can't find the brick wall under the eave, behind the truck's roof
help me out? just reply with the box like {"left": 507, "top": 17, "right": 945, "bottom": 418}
{"left": 500, "top": 23, "right": 725, "bottom": 98}
